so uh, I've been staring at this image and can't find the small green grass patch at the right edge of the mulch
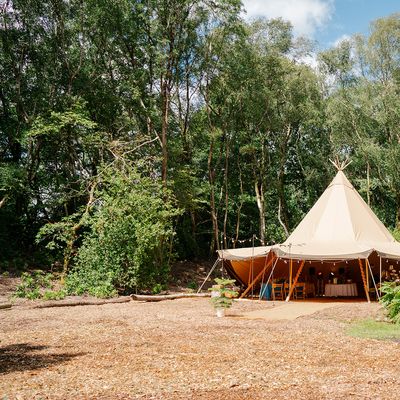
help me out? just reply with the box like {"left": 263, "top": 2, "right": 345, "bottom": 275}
{"left": 347, "top": 319, "right": 400, "bottom": 340}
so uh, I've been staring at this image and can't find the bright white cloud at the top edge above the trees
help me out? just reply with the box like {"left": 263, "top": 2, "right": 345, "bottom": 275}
{"left": 243, "top": 0, "right": 334, "bottom": 38}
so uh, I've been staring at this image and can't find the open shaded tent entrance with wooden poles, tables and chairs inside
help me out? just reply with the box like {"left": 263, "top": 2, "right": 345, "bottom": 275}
{"left": 224, "top": 254, "right": 381, "bottom": 301}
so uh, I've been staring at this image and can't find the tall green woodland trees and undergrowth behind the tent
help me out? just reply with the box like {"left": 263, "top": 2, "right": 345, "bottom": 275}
{"left": 0, "top": 0, "right": 400, "bottom": 297}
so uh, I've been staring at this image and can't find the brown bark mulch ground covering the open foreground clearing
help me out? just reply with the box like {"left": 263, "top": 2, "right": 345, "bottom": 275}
{"left": 0, "top": 298, "right": 400, "bottom": 400}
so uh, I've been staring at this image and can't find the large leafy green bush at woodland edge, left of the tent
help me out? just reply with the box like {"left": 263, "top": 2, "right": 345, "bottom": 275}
{"left": 66, "top": 167, "right": 178, "bottom": 297}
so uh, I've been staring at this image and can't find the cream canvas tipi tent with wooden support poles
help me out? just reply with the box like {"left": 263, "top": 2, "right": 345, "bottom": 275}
{"left": 219, "top": 169, "right": 400, "bottom": 300}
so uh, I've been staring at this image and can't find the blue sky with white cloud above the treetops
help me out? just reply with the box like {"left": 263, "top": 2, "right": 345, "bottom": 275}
{"left": 242, "top": 0, "right": 400, "bottom": 49}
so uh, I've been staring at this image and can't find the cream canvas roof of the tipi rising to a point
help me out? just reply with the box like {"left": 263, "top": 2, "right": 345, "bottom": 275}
{"left": 219, "top": 170, "right": 400, "bottom": 260}
